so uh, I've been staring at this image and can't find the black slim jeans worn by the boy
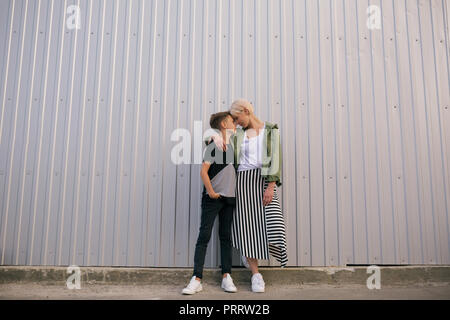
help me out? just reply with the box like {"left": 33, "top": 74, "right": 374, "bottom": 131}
{"left": 193, "top": 194, "right": 236, "bottom": 279}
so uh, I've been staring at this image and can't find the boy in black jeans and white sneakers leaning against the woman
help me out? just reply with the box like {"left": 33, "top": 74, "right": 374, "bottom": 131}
{"left": 182, "top": 112, "right": 237, "bottom": 294}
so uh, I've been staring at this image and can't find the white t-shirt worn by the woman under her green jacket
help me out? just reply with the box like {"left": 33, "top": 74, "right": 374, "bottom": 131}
{"left": 238, "top": 123, "right": 266, "bottom": 171}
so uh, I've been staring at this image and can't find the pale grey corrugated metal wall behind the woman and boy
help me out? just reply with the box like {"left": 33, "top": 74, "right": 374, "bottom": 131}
{"left": 0, "top": 0, "right": 450, "bottom": 267}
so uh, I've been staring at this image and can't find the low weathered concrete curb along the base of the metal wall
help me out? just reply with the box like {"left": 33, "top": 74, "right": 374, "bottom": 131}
{"left": 0, "top": 266, "right": 450, "bottom": 286}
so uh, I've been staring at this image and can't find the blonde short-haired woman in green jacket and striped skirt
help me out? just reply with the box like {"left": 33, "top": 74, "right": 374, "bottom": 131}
{"left": 214, "top": 99, "right": 287, "bottom": 292}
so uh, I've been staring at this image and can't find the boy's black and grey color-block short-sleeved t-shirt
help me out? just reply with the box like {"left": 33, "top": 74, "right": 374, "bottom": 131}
{"left": 202, "top": 142, "right": 236, "bottom": 198}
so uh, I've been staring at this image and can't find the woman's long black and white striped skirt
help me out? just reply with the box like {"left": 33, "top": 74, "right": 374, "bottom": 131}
{"left": 232, "top": 169, "right": 288, "bottom": 267}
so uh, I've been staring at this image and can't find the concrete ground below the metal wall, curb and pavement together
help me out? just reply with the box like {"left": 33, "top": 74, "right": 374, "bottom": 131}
{"left": 0, "top": 266, "right": 450, "bottom": 300}
